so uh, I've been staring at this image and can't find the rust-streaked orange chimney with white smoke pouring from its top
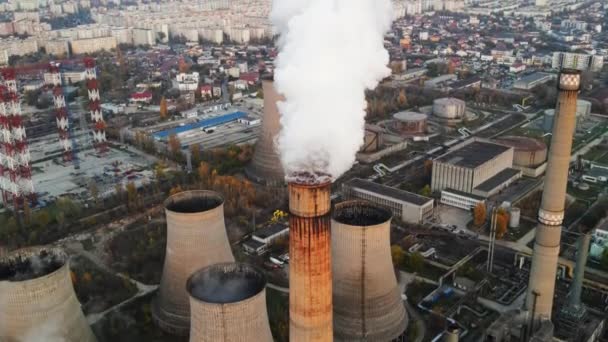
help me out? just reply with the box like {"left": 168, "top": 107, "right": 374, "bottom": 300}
{"left": 289, "top": 177, "right": 333, "bottom": 342}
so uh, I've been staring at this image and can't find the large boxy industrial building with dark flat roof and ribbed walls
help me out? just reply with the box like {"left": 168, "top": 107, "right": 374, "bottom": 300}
{"left": 431, "top": 139, "right": 521, "bottom": 196}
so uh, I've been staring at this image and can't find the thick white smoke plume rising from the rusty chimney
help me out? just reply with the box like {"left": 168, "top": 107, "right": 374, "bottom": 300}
{"left": 271, "top": 0, "right": 392, "bottom": 179}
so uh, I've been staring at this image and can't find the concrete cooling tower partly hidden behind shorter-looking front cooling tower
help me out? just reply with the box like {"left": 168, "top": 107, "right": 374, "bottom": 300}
{"left": 152, "top": 191, "right": 234, "bottom": 336}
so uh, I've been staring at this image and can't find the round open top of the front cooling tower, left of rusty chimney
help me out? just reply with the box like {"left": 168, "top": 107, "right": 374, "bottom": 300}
{"left": 186, "top": 262, "right": 267, "bottom": 305}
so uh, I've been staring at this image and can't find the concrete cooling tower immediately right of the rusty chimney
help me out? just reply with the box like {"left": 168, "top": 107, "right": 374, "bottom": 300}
{"left": 331, "top": 201, "right": 407, "bottom": 342}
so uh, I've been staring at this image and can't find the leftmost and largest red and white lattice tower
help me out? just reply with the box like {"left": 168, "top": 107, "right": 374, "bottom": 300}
{"left": 2, "top": 68, "right": 36, "bottom": 206}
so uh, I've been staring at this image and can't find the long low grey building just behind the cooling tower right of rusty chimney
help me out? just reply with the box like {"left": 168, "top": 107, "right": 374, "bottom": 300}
{"left": 342, "top": 178, "right": 434, "bottom": 223}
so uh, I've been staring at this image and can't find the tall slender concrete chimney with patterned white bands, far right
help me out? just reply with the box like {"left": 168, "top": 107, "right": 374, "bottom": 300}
{"left": 525, "top": 70, "right": 580, "bottom": 320}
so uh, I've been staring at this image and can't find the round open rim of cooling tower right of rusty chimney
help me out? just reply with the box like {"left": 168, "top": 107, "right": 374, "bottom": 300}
{"left": 332, "top": 200, "right": 393, "bottom": 228}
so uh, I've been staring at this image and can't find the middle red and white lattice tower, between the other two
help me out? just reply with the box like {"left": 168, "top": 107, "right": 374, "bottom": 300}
{"left": 49, "top": 62, "right": 74, "bottom": 162}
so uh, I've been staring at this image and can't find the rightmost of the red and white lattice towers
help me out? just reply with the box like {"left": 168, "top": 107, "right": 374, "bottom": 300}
{"left": 84, "top": 57, "right": 108, "bottom": 152}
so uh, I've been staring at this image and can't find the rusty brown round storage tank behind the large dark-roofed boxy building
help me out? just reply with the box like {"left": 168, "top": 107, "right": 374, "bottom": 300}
{"left": 496, "top": 136, "right": 547, "bottom": 168}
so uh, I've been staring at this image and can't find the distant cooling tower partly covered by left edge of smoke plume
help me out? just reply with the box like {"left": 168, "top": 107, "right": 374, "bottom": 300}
{"left": 245, "top": 75, "right": 285, "bottom": 186}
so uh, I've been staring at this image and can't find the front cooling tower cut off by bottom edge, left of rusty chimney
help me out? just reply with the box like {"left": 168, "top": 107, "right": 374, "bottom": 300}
{"left": 186, "top": 263, "right": 273, "bottom": 342}
